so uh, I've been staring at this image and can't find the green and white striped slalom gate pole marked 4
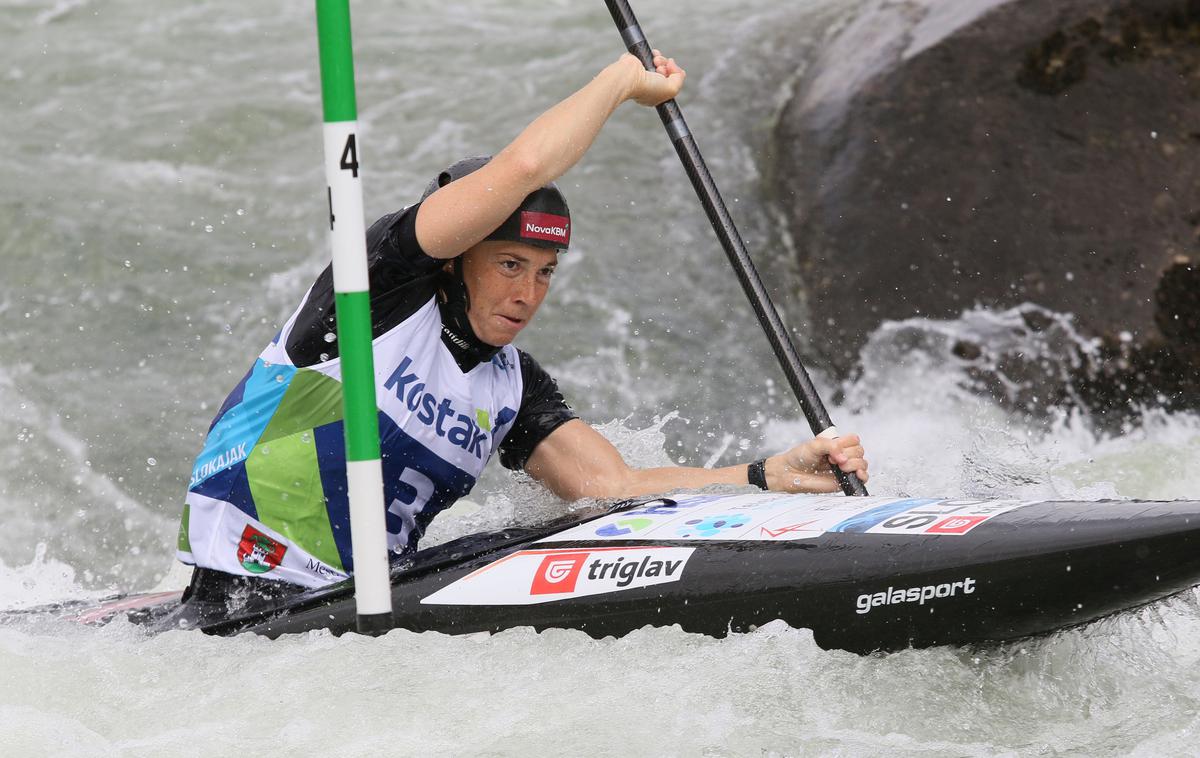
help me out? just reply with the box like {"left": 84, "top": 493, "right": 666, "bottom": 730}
{"left": 317, "top": 0, "right": 392, "bottom": 634}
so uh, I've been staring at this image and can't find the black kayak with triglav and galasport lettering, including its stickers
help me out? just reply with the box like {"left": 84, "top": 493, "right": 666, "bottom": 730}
{"left": 30, "top": 494, "right": 1200, "bottom": 652}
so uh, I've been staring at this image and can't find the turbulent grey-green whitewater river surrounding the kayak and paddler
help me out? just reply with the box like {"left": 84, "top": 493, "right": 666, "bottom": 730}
{"left": 0, "top": 0, "right": 1200, "bottom": 757}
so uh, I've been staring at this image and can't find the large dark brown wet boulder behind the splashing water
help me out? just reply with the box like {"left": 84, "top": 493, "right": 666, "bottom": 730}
{"left": 764, "top": 0, "right": 1200, "bottom": 407}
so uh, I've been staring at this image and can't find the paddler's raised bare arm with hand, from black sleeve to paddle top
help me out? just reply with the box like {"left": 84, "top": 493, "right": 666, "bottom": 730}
{"left": 416, "top": 50, "right": 685, "bottom": 259}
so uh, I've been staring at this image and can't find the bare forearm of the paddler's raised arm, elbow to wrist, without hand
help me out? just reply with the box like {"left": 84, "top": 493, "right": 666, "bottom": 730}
{"left": 497, "top": 58, "right": 642, "bottom": 192}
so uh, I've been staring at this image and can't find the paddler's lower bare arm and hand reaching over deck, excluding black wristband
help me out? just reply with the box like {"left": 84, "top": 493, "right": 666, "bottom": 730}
{"left": 526, "top": 419, "right": 868, "bottom": 500}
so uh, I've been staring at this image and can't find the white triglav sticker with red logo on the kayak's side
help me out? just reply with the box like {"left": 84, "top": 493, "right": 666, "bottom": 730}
{"left": 421, "top": 547, "right": 696, "bottom": 606}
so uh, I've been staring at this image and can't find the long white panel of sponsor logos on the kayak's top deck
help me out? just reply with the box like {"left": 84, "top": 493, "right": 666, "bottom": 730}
{"left": 540, "top": 494, "right": 1032, "bottom": 542}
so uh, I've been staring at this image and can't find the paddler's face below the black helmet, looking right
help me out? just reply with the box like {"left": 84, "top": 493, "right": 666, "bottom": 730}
{"left": 462, "top": 240, "right": 558, "bottom": 347}
